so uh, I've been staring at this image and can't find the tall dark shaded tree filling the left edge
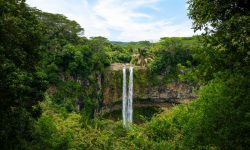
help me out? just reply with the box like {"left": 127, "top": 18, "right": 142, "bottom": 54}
{"left": 0, "top": 0, "right": 47, "bottom": 149}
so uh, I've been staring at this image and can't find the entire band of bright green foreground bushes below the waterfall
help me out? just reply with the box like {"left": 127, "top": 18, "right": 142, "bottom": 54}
{"left": 33, "top": 71, "right": 250, "bottom": 150}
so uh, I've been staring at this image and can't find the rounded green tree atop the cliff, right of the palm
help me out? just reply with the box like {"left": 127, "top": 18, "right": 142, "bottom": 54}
{"left": 150, "top": 38, "right": 192, "bottom": 80}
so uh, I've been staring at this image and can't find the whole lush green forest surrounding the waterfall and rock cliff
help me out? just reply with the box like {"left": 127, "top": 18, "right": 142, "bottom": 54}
{"left": 0, "top": 0, "right": 250, "bottom": 150}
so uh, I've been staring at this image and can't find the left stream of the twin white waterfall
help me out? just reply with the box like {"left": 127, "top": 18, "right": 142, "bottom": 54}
{"left": 122, "top": 65, "right": 127, "bottom": 126}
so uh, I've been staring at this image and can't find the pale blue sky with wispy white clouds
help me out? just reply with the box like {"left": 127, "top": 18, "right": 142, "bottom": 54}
{"left": 26, "top": 0, "right": 195, "bottom": 42}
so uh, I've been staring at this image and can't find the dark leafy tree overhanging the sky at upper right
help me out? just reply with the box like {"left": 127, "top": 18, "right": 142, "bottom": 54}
{"left": 188, "top": 0, "right": 250, "bottom": 80}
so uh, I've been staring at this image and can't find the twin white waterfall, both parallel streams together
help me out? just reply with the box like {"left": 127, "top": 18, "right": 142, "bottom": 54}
{"left": 122, "top": 65, "right": 133, "bottom": 127}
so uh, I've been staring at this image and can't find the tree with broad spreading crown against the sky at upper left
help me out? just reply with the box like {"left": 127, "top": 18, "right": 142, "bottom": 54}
{"left": 32, "top": 8, "right": 84, "bottom": 48}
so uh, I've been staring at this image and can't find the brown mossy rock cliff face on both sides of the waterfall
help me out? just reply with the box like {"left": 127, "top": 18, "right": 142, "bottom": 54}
{"left": 102, "top": 64, "right": 193, "bottom": 112}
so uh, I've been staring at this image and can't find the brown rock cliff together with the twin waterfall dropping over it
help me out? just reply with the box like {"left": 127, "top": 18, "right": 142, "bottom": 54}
{"left": 98, "top": 63, "right": 194, "bottom": 122}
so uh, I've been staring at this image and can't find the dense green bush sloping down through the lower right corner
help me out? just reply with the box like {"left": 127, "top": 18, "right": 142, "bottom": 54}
{"left": 146, "top": 75, "right": 250, "bottom": 149}
